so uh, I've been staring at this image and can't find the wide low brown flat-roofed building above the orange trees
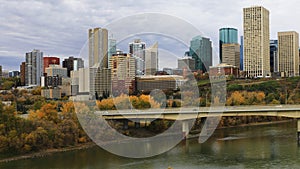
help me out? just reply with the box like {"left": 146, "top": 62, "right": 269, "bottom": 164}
{"left": 136, "top": 75, "right": 186, "bottom": 92}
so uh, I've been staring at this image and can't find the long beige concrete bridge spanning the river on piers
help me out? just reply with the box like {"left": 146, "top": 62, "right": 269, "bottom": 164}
{"left": 95, "top": 105, "right": 300, "bottom": 143}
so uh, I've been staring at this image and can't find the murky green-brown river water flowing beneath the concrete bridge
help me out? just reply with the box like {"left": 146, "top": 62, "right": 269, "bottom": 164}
{"left": 0, "top": 122, "right": 300, "bottom": 169}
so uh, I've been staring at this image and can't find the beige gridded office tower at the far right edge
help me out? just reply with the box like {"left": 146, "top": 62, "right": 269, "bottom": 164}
{"left": 278, "top": 31, "right": 299, "bottom": 77}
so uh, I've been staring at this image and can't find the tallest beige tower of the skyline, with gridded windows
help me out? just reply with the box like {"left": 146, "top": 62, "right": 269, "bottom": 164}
{"left": 243, "top": 6, "right": 271, "bottom": 77}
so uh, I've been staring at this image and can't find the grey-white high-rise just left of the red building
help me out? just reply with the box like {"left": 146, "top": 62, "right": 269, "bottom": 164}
{"left": 25, "top": 49, "right": 44, "bottom": 86}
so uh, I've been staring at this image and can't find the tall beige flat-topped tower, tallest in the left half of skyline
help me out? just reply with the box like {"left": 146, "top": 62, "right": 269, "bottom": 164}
{"left": 89, "top": 28, "right": 108, "bottom": 68}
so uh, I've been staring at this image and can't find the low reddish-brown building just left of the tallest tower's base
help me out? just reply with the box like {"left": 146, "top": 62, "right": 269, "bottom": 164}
{"left": 209, "top": 63, "right": 239, "bottom": 78}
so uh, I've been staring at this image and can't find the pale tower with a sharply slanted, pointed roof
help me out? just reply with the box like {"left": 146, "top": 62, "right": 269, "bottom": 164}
{"left": 145, "top": 42, "right": 158, "bottom": 75}
